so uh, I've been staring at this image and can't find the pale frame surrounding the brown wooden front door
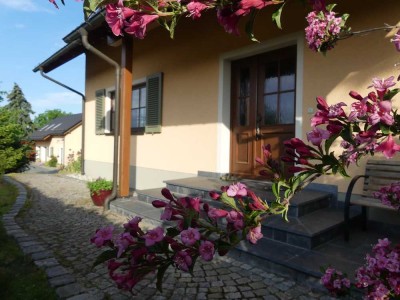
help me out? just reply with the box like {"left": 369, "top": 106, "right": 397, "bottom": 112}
{"left": 216, "top": 32, "right": 304, "bottom": 173}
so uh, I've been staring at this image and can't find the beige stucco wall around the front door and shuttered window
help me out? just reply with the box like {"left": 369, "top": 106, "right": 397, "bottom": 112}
{"left": 85, "top": 0, "right": 400, "bottom": 191}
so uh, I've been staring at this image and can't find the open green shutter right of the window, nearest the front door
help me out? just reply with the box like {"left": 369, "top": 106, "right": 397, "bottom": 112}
{"left": 144, "top": 73, "right": 163, "bottom": 133}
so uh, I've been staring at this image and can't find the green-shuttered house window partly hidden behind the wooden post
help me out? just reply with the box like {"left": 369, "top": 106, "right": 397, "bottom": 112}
{"left": 96, "top": 73, "right": 162, "bottom": 134}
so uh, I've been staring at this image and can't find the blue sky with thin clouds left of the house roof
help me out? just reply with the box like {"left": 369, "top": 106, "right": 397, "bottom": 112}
{"left": 0, "top": 0, "right": 85, "bottom": 116}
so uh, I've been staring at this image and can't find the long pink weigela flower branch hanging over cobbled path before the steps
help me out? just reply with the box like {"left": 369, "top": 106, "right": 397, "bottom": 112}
{"left": 91, "top": 183, "right": 270, "bottom": 290}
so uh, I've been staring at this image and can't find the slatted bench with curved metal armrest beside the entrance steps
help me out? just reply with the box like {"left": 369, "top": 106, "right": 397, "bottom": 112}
{"left": 344, "top": 160, "right": 400, "bottom": 241}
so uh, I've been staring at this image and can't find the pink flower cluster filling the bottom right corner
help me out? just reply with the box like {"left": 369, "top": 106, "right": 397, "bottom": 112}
{"left": 356, "top": 238, "right": 400, "bottom": 300}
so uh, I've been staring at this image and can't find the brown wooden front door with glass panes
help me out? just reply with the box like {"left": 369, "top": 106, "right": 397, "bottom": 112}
{"left": 231, "top": 46, "right": 296, "bottom": 177}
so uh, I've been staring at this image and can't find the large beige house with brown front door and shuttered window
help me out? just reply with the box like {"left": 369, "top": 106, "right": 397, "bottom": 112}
{"left": 34, "top": 0, "right": 400, "bottom": 218}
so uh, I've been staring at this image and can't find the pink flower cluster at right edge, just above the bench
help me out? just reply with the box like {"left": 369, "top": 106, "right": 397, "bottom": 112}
{"left": 307, "top": 76, "right": 400, "bottom": 164}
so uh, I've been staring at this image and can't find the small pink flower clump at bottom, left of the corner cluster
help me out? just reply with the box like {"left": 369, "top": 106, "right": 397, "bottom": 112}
{"left": 321, "top": 267, "right": 351, "bottom": 296}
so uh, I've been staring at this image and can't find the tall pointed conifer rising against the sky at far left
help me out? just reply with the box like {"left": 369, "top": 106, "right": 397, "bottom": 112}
{"left": 4, "top": 83, "right": 34, "bottom": 138}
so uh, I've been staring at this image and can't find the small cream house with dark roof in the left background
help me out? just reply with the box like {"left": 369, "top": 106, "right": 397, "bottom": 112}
{"left": 29, "top": 114, "right": 82, "bottom": 165}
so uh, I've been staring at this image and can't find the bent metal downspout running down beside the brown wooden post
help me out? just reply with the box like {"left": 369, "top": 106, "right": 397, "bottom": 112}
{"left": 79, "top": 28, "right": 121, "bottom": 210}
